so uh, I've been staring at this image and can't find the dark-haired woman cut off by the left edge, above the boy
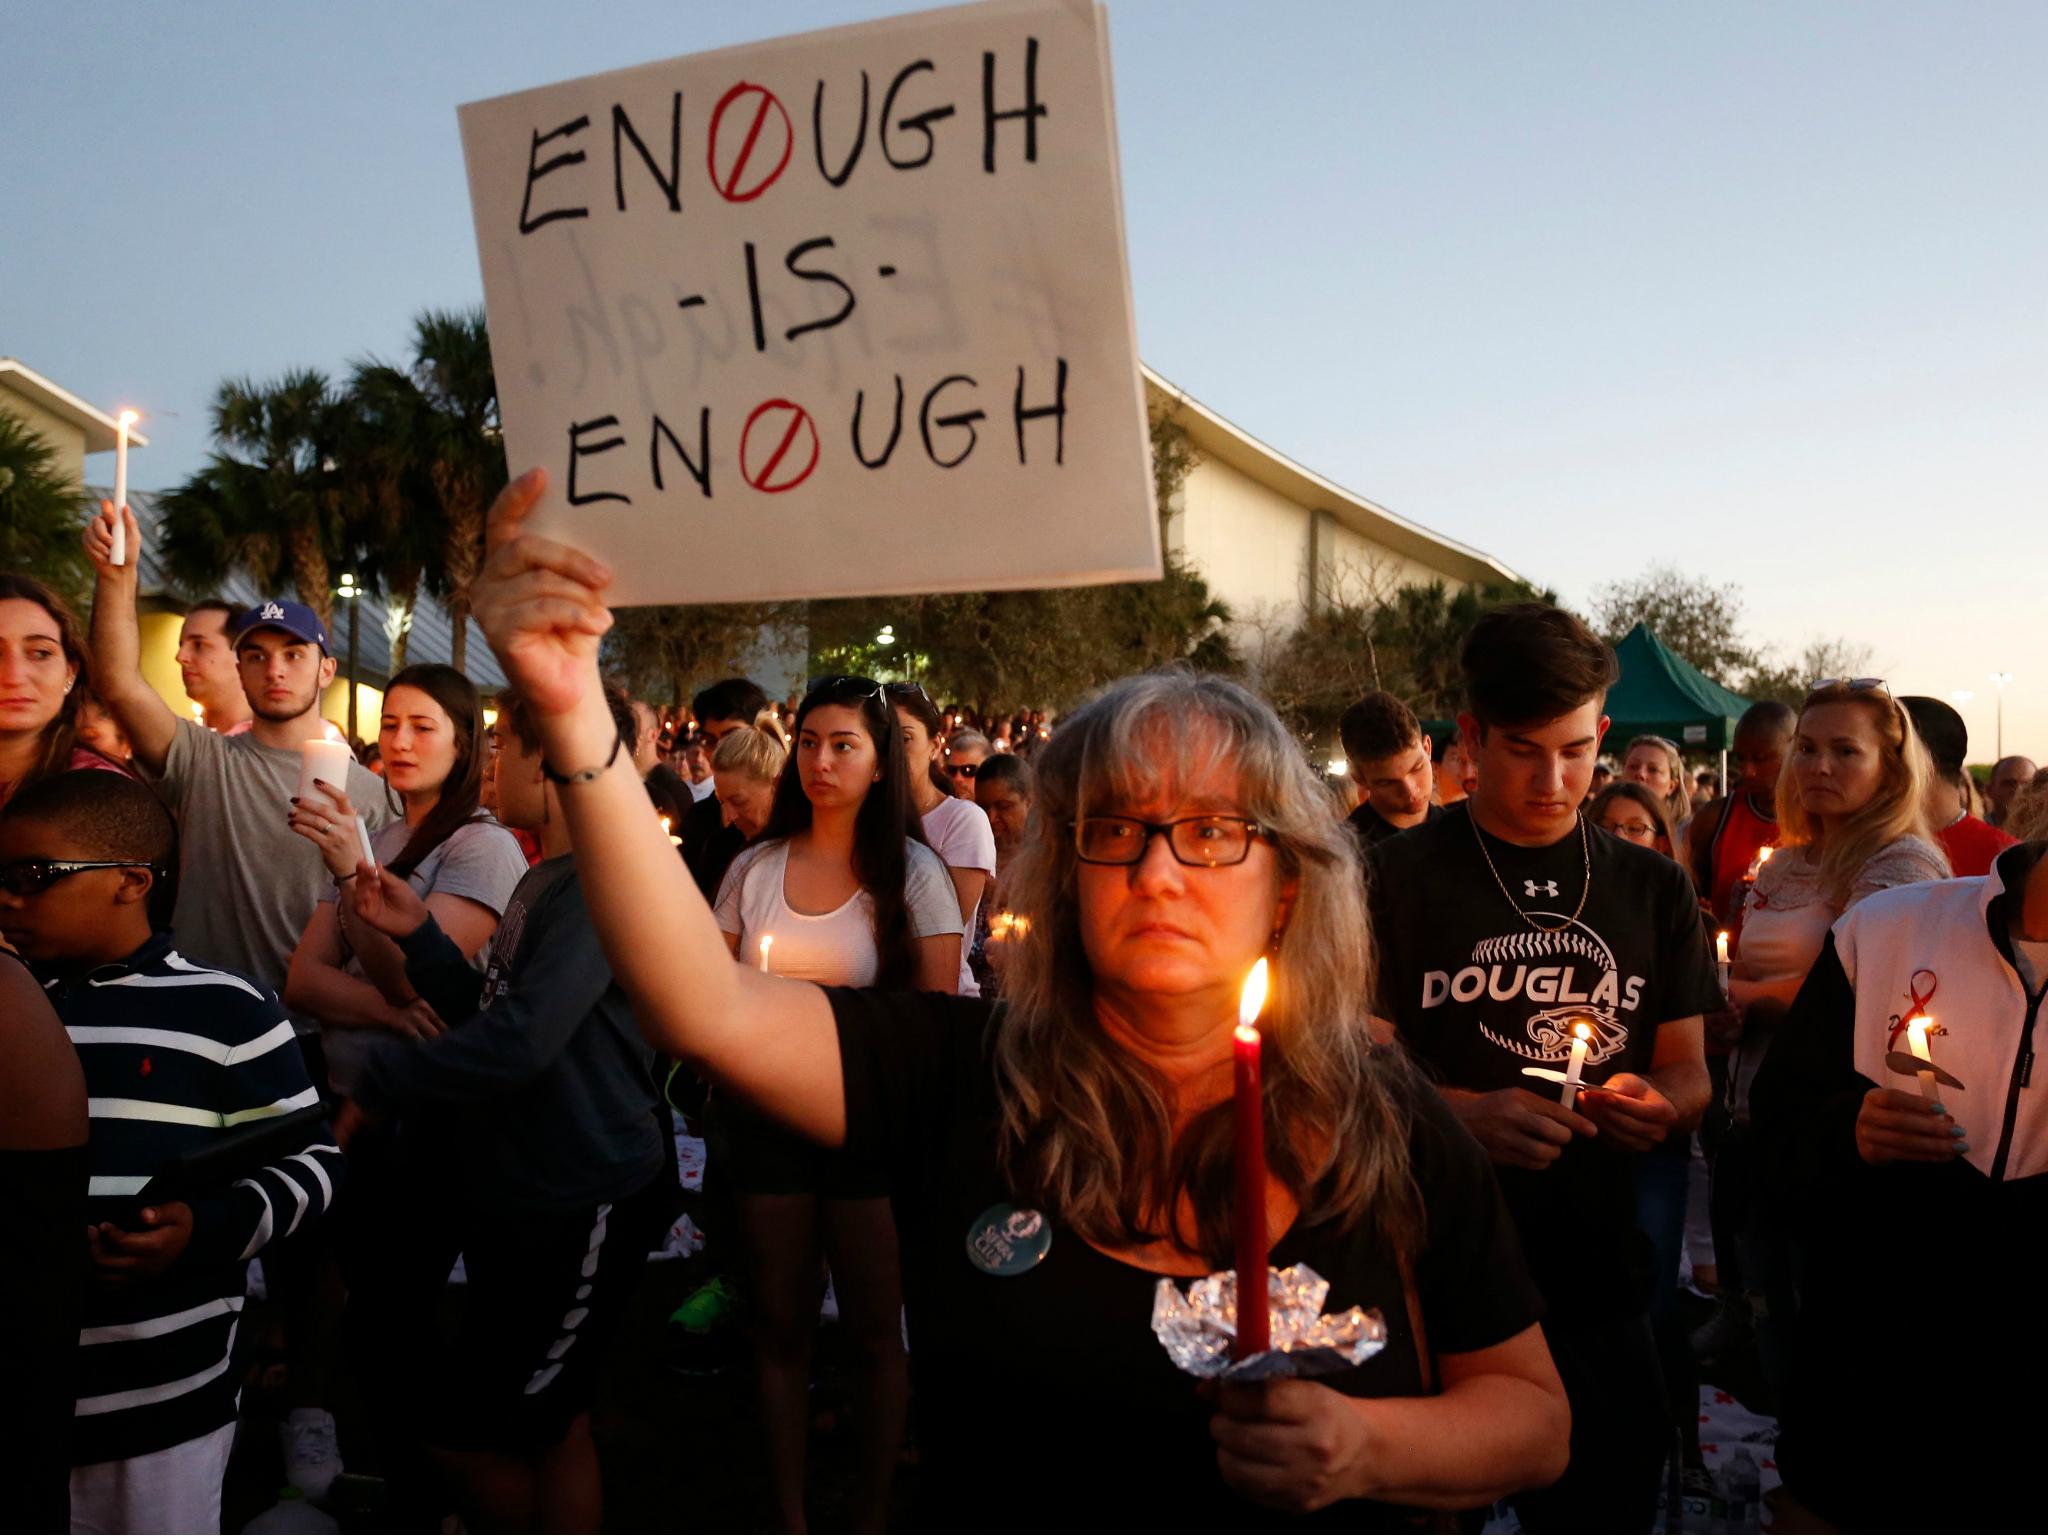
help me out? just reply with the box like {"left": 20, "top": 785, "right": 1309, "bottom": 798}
{"left": 0, "top": 571, "right": 123, "bottom": 819}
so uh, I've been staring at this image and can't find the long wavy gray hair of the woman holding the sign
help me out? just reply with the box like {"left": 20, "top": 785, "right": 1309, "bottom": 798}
{"left": 995, "top": 668, "right": 1419, "bottom": 1268}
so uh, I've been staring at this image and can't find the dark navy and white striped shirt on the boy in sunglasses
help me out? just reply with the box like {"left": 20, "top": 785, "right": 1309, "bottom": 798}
{"left": 39, "top": 934, "right": 342, "bottom": 1466}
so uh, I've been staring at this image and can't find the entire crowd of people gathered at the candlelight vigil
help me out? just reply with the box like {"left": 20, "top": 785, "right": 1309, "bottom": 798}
{"left": 0, "top": 487, "right": 2048, "bottom": 1530}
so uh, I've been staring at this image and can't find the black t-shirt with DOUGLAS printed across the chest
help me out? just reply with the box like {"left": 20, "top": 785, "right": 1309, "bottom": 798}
{"left": 1368, "top": 803, "right": 1722, "bottom": 1325}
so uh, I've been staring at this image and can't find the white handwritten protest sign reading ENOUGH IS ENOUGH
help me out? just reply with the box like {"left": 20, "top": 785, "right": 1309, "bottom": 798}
{"left": 461, "top": 0, "right": 1159, "bottom": 606}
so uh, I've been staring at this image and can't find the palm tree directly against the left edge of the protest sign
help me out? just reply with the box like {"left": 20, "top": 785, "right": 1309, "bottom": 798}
{"left": 412, "top": 309, "right": 506, "bottom": 670}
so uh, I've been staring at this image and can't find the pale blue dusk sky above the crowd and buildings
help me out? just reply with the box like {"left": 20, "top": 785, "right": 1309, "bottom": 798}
{"left": 0, "top": 0, "right": 2048, "bottom": 760}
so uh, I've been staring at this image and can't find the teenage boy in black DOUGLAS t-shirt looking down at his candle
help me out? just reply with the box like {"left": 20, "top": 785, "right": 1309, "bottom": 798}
{"left": 1368, "top": 604, "right": 1720, "bottom": 1530}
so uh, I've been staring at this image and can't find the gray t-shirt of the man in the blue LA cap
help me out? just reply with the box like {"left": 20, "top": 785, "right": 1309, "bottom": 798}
{"left": 137, "top": 721, "right": 393, "bottom": 1011}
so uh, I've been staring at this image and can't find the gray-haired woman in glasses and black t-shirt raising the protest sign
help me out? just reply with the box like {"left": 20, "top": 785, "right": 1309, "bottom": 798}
{"left": 460, "top": 471, "right": 1569, "bottom": 1530}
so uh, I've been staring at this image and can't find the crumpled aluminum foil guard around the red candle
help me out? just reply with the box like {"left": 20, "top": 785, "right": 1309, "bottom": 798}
{"left": 1153, "top": 1264, "right": 1386, "bottom": 1380}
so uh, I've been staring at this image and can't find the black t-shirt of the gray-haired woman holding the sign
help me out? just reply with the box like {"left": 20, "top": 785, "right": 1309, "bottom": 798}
{"left": 827, "top": 989, "right": 1540, "bottom": 1530}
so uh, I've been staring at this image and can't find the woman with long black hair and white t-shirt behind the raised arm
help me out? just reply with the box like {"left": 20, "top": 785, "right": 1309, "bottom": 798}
{"left": 712, "top": 678, "right": 963, "bottom": 1530}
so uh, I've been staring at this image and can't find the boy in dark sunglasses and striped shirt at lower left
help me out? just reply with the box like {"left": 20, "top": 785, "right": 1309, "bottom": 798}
{"left": 0, "top": 772, "right": 342, "bottom": 1530}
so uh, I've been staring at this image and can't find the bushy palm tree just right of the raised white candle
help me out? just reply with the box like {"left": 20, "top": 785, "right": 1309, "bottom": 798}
{"left": 162, "top": 369, "right": 348, "bottom": 625}
